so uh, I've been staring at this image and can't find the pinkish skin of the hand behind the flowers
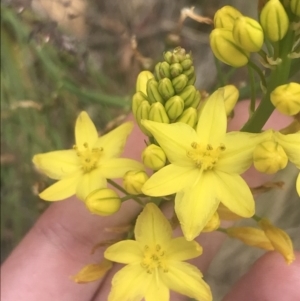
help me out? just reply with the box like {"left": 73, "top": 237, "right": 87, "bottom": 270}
{"left": 1, "top": 103, "right": 300, "bottom": 301}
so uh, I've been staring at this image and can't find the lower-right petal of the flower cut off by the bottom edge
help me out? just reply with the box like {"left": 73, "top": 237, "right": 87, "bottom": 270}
{"left": 160, "top": 261, "right": 212, "bottom": 301}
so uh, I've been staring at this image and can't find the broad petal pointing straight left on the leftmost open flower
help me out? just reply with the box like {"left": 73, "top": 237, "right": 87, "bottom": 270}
{"left": 32, "top": 150, "right": 80, "bottom": 180}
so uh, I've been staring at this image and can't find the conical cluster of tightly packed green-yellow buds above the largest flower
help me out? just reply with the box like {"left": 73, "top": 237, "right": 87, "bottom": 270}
{"left": 132, "top": 47, "right": 201, "bottom": 136}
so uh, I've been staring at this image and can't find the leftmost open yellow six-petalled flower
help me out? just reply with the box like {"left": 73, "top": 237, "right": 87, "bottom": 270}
{"left": 33, "top": 112, "right": 143, "bottom": 201}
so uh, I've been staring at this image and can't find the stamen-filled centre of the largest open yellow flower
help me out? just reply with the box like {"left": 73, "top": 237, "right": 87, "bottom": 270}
{"left": 187, "top": 142, "right": 226, "bottom": 170}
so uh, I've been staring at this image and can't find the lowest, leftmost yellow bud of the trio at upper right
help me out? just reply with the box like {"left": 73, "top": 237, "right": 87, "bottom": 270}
{"left": 209, "top": 28, "right": 249, "bottom": 67}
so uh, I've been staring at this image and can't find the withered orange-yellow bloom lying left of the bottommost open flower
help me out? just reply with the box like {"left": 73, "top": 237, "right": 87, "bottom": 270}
{"left": 72, "top": 259, "right": 112, "bottom": 283}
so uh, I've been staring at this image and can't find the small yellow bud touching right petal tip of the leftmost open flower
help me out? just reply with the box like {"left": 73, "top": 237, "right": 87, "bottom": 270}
{"left": 123, "top": 170, "right": 149, "bottom": 195}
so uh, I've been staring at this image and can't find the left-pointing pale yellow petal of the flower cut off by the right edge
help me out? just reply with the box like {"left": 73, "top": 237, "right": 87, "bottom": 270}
{"left": 274, "top": 131, "right": 300, "bottom": 168}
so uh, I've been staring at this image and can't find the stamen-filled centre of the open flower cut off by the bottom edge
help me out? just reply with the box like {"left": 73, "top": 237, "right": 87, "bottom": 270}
{"left": 141, "top": 245, "right": 168, "bottom": 274}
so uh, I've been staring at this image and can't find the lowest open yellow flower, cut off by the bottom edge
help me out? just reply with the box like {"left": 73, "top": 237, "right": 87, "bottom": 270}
{"left": 104, "top": 203, "right": 212, "bottom": 301}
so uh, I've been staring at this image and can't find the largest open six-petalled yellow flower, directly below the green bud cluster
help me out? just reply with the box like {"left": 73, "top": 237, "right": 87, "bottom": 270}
{"left": 142, "top": 89, "right": 264, "bottom": 240}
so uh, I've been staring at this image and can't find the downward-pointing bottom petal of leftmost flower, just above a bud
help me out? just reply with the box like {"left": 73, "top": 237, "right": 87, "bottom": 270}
{"left": 76, "top": 169, "right": 107, "bottom": 201}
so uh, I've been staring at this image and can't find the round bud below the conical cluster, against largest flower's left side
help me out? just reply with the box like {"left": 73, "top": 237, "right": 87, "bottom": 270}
{"left": 142, "top": 144, "right": 167, "bottom": 170}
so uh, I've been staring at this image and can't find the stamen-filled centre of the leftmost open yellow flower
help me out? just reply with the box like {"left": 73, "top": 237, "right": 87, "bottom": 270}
{"left": 73, "top": 143, "right": 103, "bottom": 173}
